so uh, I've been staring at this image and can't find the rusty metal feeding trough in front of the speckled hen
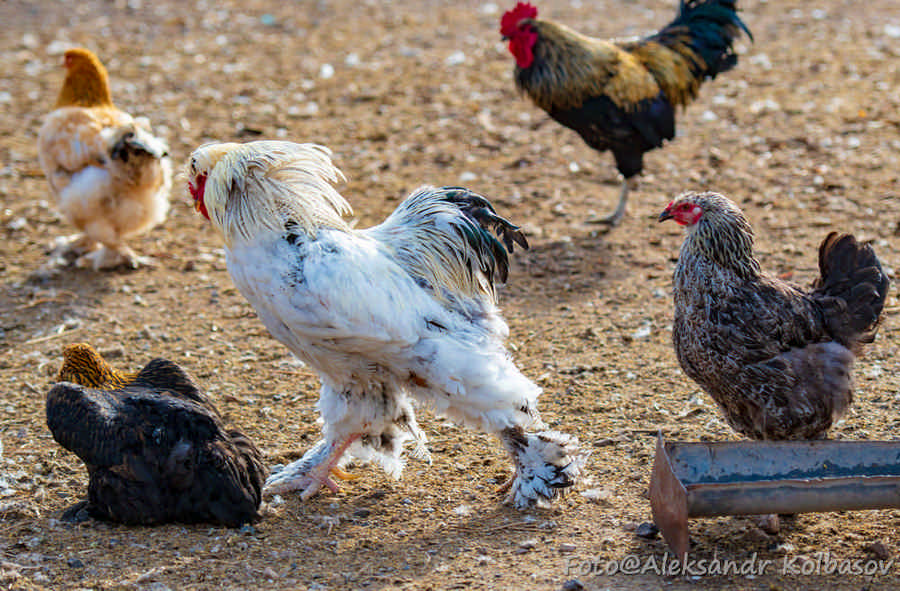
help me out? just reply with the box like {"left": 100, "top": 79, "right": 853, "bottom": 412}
{"left": 650, "top": 434, "right": 900, "bottom": 558}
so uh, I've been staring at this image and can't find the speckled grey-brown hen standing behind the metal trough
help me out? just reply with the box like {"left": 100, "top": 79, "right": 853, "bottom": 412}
{"left": 659, "top": 193, "right": 888, "bottom": 440}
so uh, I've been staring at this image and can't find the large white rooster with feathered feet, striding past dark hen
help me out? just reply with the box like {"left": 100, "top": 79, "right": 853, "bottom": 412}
{"left": 187, "top": 141, "right": 585, "bottom": 508}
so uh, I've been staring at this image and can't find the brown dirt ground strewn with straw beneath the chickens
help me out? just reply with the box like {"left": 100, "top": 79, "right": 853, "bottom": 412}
{"left": 0, "top": 0, "right": 900, "bottom": 591}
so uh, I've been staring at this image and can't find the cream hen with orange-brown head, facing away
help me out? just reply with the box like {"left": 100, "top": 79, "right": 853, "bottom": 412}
{"left": 38, "top": 48, "right": 172, "bottom": 269}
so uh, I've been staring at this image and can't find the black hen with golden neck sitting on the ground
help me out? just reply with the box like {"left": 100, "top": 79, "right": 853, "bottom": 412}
{"left": 47, "top": 344, "right": 268, "bottom": 526}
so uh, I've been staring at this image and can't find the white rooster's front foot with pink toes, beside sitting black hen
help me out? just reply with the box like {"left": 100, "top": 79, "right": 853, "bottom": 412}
{"left": 263, "top": 435, "right": 359, "bottom": 501}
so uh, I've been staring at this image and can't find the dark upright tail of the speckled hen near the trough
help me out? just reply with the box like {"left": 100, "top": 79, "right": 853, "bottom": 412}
{"left": 813, "top": 232, "right": 889, "bottom": 352}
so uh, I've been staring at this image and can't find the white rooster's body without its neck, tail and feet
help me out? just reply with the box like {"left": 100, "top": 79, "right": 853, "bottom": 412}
{"left": 226, "top": 197, "right": 541, "bottom": 476}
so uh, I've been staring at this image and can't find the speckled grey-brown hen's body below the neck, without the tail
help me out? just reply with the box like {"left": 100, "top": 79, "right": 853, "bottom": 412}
{"left": 673, "top": 275, "right": 853, "bottom": 439}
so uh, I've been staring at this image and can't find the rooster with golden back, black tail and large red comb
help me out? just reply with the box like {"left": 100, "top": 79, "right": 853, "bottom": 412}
{"left": 500, "top": 0, "right": 753, "bottom": 225}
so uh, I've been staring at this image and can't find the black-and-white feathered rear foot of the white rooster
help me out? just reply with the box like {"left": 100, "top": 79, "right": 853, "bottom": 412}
{"left": 500, "top": 427, "right": 587, "bottom": 509}
